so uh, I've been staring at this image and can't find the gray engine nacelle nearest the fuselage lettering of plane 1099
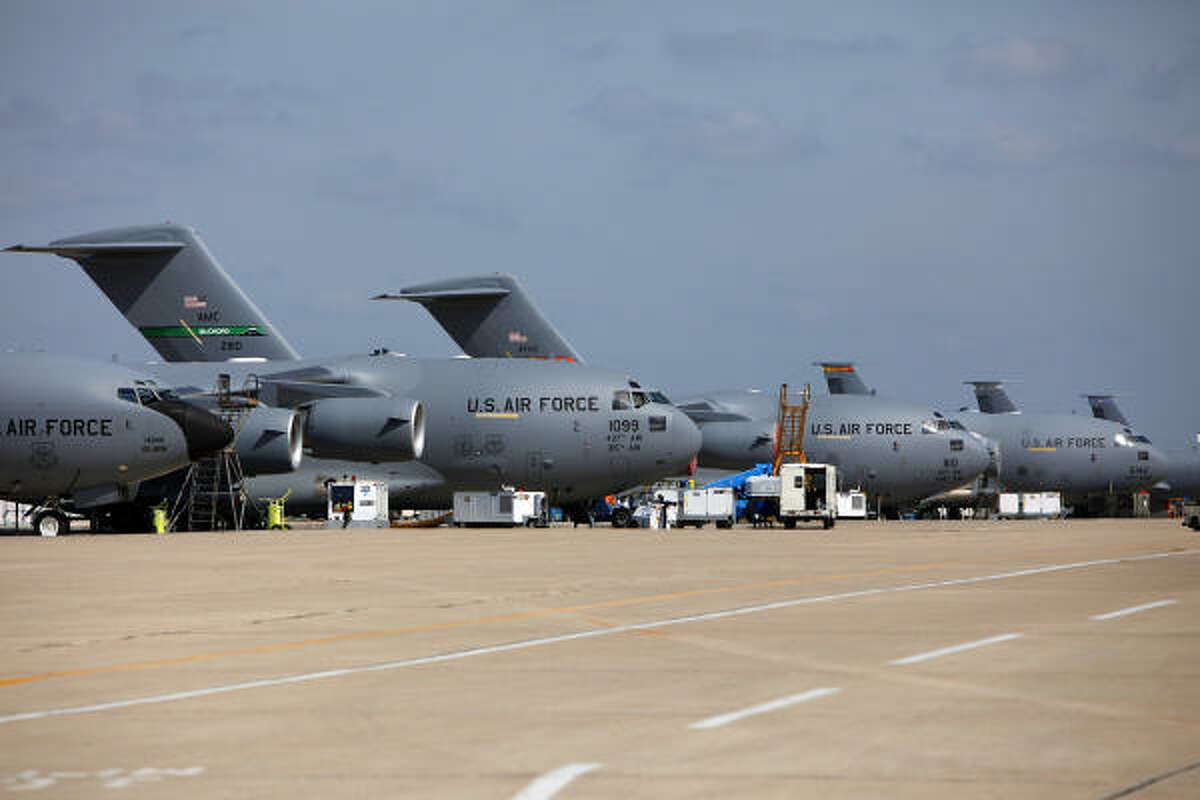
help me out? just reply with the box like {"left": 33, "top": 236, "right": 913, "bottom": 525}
{"left": 305, "top": 397, "right": 425, "bottom": 462}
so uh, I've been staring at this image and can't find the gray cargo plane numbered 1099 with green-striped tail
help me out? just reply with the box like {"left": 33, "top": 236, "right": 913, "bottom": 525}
{"left": 8, "top": 224, "right": 700, "bottom": 520}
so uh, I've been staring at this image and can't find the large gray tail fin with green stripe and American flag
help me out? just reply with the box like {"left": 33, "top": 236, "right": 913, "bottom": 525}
{"left": 7, "top": 224, "right": 300, "bottom": 361}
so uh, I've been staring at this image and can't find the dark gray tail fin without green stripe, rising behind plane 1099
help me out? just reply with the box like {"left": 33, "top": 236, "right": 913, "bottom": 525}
{"left": 372, "top": 273, "right": 583, "bottom": 362}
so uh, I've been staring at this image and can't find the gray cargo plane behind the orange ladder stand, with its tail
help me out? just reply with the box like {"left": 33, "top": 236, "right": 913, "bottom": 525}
{"left": 377, "top": 275, "right": 990, "bottom": 506}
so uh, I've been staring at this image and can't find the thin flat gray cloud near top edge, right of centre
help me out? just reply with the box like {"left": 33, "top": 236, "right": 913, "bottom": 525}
{"left": 661, "top": 29, "right": 904, "bottom": 67}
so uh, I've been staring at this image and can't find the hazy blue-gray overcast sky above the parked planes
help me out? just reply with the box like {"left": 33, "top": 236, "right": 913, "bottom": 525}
{"left": 0, "top": 0, "right": 1200, "bottom": 446}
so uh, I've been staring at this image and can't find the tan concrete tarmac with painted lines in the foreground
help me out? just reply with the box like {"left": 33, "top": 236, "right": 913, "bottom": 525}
{"left": 0, "top": 519, "right": 1200, "bottom": 800}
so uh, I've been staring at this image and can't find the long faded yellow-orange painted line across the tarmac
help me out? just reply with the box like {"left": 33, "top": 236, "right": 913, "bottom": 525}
{"left": 0, "top": 564, "right": 950, "bottom": 686}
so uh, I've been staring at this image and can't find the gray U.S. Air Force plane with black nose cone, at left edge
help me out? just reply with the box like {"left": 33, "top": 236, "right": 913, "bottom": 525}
{"left": 0, "top": 353, "right": 233, "bottom": 535}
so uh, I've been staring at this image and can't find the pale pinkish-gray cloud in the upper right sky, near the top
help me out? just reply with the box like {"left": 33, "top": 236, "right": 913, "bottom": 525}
{"left": 946, "top": 36, "right": 1103, "bottom": 89}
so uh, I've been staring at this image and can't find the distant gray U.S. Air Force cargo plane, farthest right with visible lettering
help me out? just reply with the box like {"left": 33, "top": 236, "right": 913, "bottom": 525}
{"left": 827, "top": 362, "right": 1164, "bottom": 503}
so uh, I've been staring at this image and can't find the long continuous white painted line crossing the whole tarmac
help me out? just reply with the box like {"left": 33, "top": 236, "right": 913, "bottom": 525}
{"left": 0, "top": 549, "right": 1200, "bottom": 724}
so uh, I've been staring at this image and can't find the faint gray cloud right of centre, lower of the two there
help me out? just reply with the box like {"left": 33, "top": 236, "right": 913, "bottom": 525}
{"left": 576, "top": 88, "right": 826, "bottom": 164}
